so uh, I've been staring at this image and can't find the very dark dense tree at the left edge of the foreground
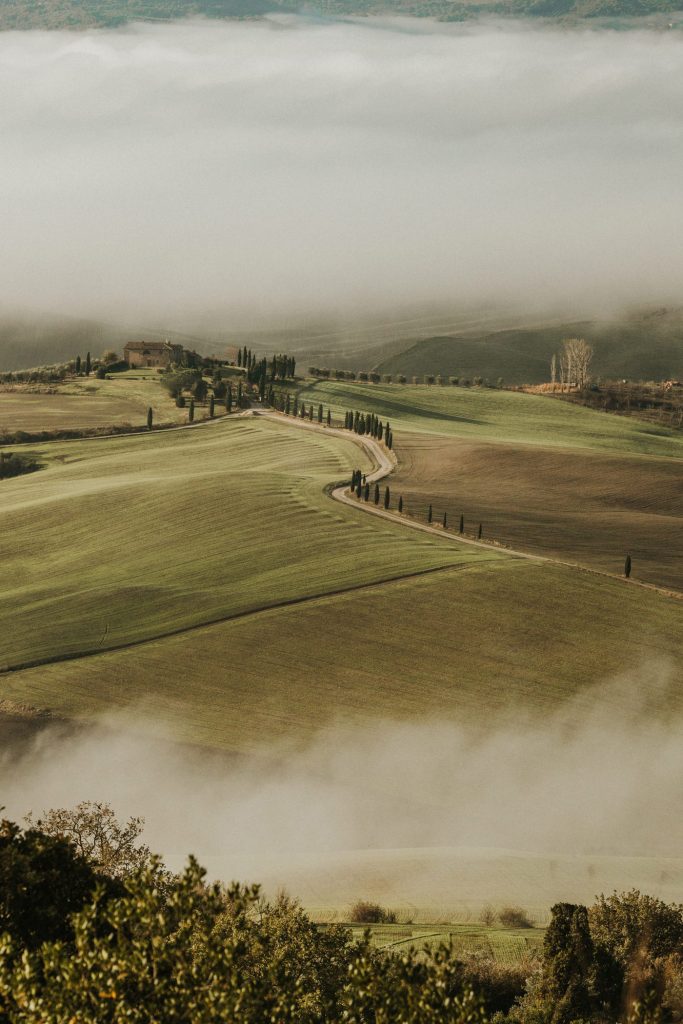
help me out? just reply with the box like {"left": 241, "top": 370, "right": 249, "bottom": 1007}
{"left": 0, "top": 820, "right": 120, "bottom": 950}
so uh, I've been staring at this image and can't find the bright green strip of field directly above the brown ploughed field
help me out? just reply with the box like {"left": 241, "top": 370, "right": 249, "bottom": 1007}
{"left": 299, "top": 381, "right": 683, "bottom": 458}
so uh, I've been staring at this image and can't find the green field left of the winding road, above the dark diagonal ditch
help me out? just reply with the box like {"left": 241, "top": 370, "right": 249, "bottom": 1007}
{"left": 0, "top": 417, "right": 491, "bottom": 668}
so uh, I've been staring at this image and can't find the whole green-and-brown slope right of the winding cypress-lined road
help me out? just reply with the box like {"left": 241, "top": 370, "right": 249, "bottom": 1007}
{"left": 290, "top": 384, "right": 683, "bottom": 590}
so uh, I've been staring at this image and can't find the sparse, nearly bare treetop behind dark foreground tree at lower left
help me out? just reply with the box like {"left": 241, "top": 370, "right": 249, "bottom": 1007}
{"left": 26, "top": 801, "right": 152, "bottom": 879}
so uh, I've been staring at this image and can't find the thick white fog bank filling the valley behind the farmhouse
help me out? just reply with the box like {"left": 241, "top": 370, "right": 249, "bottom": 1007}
{"left": 0, "top": 18, "right": 683, "bottom": 319}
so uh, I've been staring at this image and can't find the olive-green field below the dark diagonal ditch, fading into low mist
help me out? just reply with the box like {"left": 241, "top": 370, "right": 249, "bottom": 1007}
{"left": 6, "top": 557, "right": 683, "bottom": 749}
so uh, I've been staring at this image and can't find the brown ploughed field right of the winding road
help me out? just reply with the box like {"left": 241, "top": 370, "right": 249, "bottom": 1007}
{"left": 392, "top": 434, "right": 683, "bottom": 590}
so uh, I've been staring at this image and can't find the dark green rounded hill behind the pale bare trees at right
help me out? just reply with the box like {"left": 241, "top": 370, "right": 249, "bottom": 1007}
{"left": 376, "top": 309, "right": 683, "bottom": 384}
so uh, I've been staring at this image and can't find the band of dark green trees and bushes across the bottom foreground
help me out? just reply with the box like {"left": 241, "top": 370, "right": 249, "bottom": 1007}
{"left": 0, "top": 804, "right": 683, "bottom": 1024}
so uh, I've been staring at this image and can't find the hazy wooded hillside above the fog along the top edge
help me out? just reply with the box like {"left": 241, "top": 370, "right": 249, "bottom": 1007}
{"left": 0, "top": 0, "right": 681, "bottom": 31}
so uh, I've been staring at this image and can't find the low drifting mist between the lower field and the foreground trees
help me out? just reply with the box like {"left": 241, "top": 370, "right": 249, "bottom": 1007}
{"left": 0, "top": 665, "right": 683, "bottom": 870}
